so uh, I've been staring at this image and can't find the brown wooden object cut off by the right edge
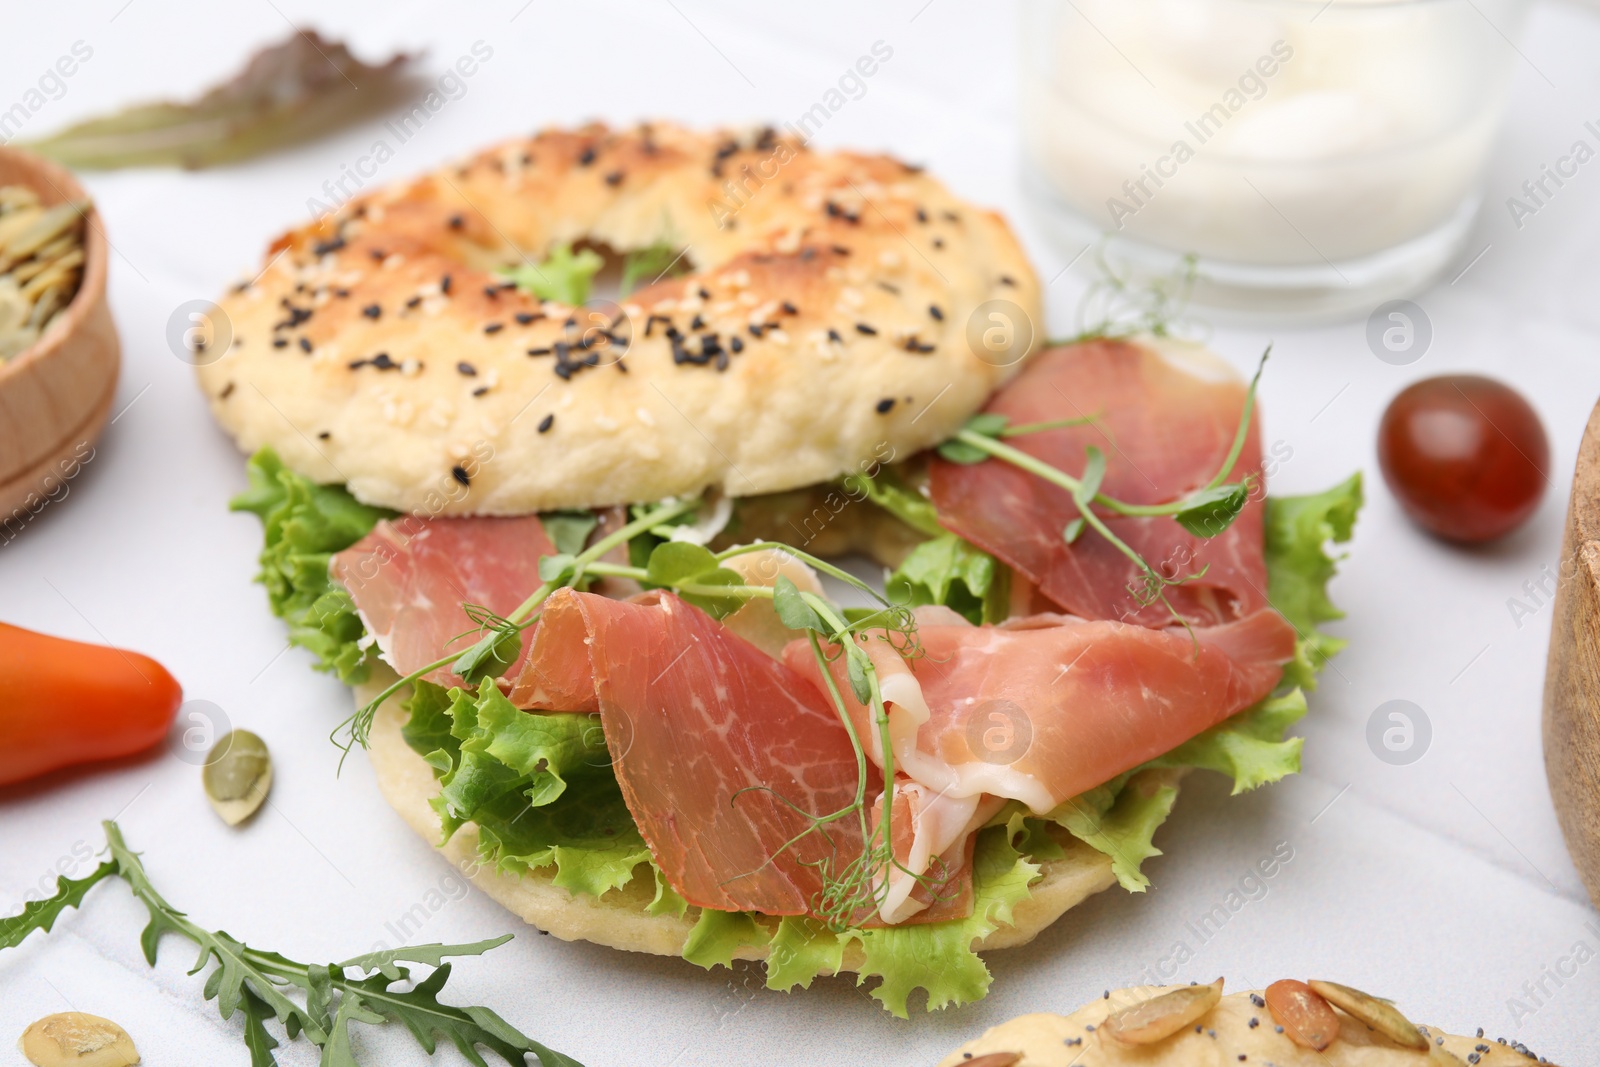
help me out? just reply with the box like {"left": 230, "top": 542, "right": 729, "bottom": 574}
{"left": 1544, "top": 396, "right": 1600, "bottom": 904}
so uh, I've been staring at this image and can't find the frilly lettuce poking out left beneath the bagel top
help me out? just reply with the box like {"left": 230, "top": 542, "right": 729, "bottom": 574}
{"left": 229, "top": 448, "right": 394, "bottom": 685}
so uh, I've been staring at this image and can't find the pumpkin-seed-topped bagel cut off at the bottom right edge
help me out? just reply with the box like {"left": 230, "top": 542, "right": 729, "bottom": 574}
{"left": 939, "top": 985, "right": 1534, "bottom": 1067}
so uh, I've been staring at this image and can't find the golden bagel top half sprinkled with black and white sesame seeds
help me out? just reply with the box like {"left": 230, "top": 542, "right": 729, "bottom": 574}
{"left": 197, "top": 125, "right": 1040, "bottom": 515}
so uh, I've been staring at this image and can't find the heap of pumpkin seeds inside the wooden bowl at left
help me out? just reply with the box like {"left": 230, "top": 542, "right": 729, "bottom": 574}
{"left": 0, "top": 186, "right": 88, "bottom": 360}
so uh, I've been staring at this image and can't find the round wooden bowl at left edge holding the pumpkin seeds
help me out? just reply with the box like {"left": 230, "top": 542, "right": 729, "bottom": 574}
{"left": 0, "top": 146, "right": 122, "bottom": 521}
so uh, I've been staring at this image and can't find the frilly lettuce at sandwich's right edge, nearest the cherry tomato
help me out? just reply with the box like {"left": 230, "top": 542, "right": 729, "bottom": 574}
{"left": 1267, "top": 470, "right": 1362, "bottom": 689}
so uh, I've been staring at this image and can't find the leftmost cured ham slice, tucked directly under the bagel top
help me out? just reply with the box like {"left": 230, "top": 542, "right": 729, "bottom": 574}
{"left": 328, "top": 515, "right": 555, "bottom": 685}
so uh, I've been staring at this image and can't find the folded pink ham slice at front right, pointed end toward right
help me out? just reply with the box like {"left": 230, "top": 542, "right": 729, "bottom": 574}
{"left": 784, "top": 609, "right": 1294, "bottom": 814}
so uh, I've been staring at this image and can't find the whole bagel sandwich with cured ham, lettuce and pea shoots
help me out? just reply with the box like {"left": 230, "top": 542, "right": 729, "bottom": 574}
{"left": 206, "top": 123, "right": 1360, "bottom": 1014}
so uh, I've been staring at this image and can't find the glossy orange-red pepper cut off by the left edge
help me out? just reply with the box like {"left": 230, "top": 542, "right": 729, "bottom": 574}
{"left": 0, "top": 622, "right": 184, "bottom": 785}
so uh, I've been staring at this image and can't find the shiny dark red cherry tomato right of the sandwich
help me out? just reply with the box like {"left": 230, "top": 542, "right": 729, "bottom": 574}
{"left": 1378, "top": 374, "right": 1550, "bottom": 544}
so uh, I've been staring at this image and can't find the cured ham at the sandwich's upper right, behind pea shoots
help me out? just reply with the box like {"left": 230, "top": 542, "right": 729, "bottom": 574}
{"left": 928, "top": 341, "right": 1267, "bottom": 627}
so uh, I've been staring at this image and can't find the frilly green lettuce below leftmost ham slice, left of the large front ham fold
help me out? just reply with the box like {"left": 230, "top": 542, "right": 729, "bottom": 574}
{"left": 403, "top": 681, "right": 646, "bottom": 895}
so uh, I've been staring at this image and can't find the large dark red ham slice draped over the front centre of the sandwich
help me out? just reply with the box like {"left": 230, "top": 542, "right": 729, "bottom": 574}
{"left": 512, "top": 589, "right": 882, "bottom": 915}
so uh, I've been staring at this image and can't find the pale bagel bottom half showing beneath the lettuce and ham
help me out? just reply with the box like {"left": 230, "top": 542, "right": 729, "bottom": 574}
{"left": 364, "top": 669, "right": 1145, "bottom": 973}
